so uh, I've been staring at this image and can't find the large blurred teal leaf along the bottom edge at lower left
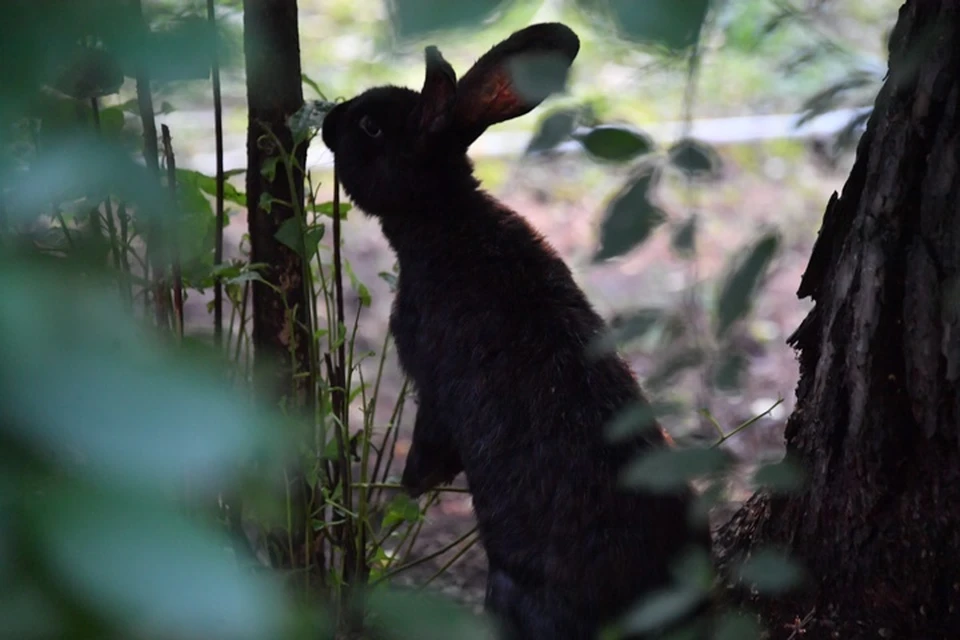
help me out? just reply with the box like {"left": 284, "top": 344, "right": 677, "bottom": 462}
{"left": 30, "top": 483, "right": 285, "bottom": 640}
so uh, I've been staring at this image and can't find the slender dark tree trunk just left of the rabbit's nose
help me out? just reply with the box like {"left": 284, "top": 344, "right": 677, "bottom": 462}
{"left": 240, "top": 0, "right": 316, "bottom": 567}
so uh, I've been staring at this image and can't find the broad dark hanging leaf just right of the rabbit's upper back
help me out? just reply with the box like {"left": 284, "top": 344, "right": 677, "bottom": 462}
{"left": 593, "top": 173, "right": 667, "bottom": 263}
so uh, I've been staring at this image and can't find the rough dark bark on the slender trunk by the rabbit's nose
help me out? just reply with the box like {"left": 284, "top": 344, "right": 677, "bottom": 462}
{"left": 243, "top": 0, "right": 310, "bottom": 407}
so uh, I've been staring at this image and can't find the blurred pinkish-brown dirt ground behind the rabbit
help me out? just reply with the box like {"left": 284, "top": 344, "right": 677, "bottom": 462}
{"left": 191, "top": 140, "right": 846, "bottom": 609}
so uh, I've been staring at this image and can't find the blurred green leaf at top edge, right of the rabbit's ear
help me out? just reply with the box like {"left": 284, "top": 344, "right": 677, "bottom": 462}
{"left": 576, "top": 0, "right": 710, "bottom": 53}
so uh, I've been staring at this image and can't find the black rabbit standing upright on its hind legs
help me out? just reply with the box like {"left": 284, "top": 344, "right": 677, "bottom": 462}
{"left": 323, "top": 24, "right": 709, "bottom": 640}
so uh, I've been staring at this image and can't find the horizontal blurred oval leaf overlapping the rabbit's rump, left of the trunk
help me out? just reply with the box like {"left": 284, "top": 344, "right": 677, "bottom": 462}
{"left": 621, "top": 448, "right": 730, "bottom": 493}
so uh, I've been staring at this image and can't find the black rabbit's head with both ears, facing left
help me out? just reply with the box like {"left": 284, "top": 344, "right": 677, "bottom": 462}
{"left": 323, "top": 23, "right": 580, "bottom": 217}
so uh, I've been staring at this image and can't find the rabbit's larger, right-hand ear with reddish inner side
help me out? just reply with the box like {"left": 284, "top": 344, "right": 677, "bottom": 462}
{"left": 454, "top": 23, "right": 580, "bottom": 145}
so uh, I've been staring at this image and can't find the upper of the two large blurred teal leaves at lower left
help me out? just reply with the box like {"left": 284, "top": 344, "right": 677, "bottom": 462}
{"left": 0, "top": 261, "right": 271, "bottom": 491}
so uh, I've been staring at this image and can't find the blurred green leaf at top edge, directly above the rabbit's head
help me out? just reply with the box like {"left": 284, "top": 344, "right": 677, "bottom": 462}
{"left": 387, "top": 0, "right": 509, "bottom": 40}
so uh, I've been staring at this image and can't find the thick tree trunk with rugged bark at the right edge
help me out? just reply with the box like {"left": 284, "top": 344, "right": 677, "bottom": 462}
{"left": 717, "top": 0, "right": 960, "bottom": 640}
